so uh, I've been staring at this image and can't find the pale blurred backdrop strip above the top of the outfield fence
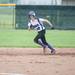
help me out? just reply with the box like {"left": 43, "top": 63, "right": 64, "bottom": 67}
{"left": 0, "top": 0, "right": 75, "bottom": 6}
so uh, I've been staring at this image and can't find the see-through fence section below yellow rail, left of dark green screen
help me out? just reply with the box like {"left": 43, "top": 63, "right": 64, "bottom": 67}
{"left": 0, "top": 7, "right": 15, "bottom": 29}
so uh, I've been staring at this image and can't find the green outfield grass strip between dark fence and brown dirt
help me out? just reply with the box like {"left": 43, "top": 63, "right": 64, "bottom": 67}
{"left": 0, "top": 30, "right": 75, "bottom": 48}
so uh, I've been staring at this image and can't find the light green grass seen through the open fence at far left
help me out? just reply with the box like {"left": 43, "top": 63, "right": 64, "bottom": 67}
{"left": 0, "top": 14, "right": 14, "bottom": 29}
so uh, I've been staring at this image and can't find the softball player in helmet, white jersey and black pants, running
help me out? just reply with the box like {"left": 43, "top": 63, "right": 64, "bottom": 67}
{"left": 28, "top": 11, "right": 55, "bottom": 54}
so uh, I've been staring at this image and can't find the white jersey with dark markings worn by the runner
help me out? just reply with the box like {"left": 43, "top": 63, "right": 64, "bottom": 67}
{"left": 28, "top": 18, "right": 45, "bottom": 32}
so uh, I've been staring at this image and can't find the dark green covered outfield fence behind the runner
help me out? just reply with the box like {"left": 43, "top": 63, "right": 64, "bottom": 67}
{"left": 16, "top": 5, "right": 75, "bottom": 29}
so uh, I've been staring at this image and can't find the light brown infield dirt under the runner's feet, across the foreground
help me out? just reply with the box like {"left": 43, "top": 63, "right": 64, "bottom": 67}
{"left": 0, "top": 48, "right": 75, "bottom": 75}
